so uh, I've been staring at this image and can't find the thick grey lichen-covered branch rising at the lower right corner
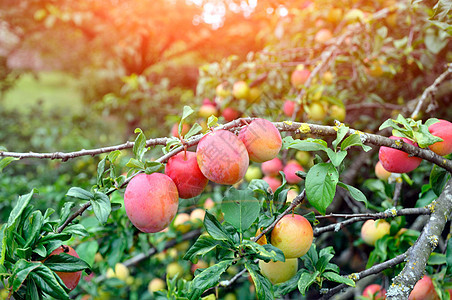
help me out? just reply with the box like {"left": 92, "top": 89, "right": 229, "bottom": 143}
{"left": 387, "top": 179, "right": 452, "bottom": 300}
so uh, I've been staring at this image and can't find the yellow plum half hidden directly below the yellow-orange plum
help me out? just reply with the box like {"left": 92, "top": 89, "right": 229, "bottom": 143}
{"left": 259, "top": 258, "right": 298, "bottom": 284}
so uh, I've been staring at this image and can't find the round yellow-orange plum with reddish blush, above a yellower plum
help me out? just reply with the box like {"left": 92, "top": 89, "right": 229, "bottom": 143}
{"left": 271, "top": 214, "right": 314, "bottom": 259}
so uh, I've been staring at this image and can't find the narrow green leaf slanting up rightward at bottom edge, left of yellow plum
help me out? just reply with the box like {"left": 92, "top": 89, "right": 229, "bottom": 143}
{"left": 189, "top": 259, "right": 233, "bottom": 299}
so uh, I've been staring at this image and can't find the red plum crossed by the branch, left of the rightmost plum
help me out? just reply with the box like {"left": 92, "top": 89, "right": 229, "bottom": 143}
{"left": 378, "top": 136, "right": 422, "bottom": 173}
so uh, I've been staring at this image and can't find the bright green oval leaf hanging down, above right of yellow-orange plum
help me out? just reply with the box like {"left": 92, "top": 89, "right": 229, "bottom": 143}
{"left": 305, "top": 163, "right": 339, "bottom": 215}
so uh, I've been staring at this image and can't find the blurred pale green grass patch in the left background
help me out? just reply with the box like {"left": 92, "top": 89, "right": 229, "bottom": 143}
{"left": 3, "top": 72, "right": 82, "bottom": 113}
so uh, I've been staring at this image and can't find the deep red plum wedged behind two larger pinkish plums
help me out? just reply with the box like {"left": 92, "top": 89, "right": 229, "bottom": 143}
{"left": 165, "top": 151, "right": 209, "bottom": 199}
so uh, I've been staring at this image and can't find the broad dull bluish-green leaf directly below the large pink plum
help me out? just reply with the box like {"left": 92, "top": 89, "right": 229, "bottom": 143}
{"left": 221, "top": 188, "right": 260, "bottom": 233}
